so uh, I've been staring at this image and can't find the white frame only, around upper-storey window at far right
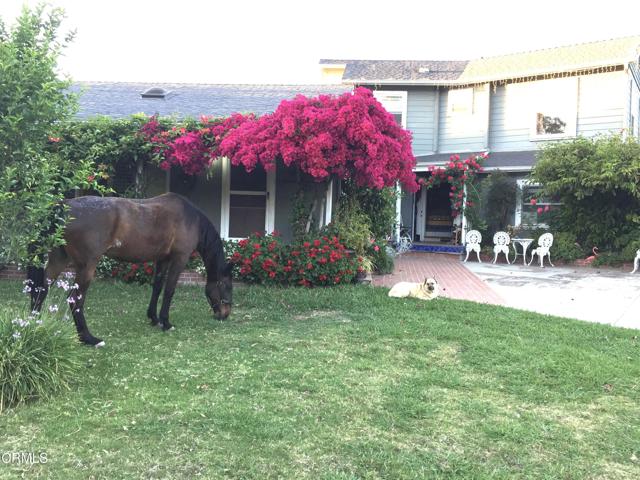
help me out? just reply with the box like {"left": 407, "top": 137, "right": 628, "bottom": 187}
{"left": 529, "top": 77, "right": 578, "bottom": 142}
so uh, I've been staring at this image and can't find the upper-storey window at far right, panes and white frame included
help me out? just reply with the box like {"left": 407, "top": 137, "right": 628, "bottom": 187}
{"left": 530, "top": 78, "right": 578, "bottom": 140}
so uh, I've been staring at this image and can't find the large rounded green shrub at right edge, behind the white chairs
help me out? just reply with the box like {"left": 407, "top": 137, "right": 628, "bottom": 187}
{"left": 532, "top": 135, "right": 640, "bottom": 251}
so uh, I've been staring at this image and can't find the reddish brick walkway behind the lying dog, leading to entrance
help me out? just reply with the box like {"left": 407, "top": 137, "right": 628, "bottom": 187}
{"left": 373, "top": 252, "right": 505, "bottom": 305}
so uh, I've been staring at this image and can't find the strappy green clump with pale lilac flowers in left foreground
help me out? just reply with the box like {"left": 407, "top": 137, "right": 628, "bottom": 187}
{"left": 0, "top": 280, "right": 82, "bottom": 412}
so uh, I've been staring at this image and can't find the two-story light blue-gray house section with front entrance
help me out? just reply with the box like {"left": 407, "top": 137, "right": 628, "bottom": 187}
{"left": 320, "top": 36, "right": 640, "bottom": 243}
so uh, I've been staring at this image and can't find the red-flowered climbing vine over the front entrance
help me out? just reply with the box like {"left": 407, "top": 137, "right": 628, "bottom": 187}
{"left": 419, "top": 153, "right": 489, "bottom": 217}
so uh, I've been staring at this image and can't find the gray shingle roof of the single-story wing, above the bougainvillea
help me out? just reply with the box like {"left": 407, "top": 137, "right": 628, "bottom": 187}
{"left": 72, "top": 82, "right": 352, "bottom": 119}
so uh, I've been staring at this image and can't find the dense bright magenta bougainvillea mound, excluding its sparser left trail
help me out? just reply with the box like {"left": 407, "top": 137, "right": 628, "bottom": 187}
{"left": 220, "top": 87, "right": 418, "bottom": 191}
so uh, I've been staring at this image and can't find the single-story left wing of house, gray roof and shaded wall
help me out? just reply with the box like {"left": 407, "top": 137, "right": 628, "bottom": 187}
{"left": 73, "top": 82, "right": 351, "bottom": 244}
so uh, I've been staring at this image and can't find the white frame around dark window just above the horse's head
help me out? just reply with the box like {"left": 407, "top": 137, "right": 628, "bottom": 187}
{"left": 220, "top": 157, "right": 276, "bottom": 240}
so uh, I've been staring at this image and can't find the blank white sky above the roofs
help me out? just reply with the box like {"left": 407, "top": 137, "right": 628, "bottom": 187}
{"left": 0, "top": 0, "right": 640, "bottom": 84}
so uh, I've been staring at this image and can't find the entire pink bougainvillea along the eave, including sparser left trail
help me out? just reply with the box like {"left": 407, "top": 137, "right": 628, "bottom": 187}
{"left": 141, "top": 88, "right": 418, "bottom": 191}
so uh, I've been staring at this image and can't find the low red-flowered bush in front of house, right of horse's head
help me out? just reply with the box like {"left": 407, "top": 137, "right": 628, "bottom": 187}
{"left": 230, "top": 234, "right": 358, "bottom": 287}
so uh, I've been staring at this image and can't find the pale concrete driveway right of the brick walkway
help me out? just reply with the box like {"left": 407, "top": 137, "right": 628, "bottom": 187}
{"left": 463, "top": 260, "right": 640, "bottom": 329}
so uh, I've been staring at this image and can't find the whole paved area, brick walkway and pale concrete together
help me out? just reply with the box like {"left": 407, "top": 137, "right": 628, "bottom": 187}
{"left": 373, "top": 252, "right": 640, "bottom": 329}
